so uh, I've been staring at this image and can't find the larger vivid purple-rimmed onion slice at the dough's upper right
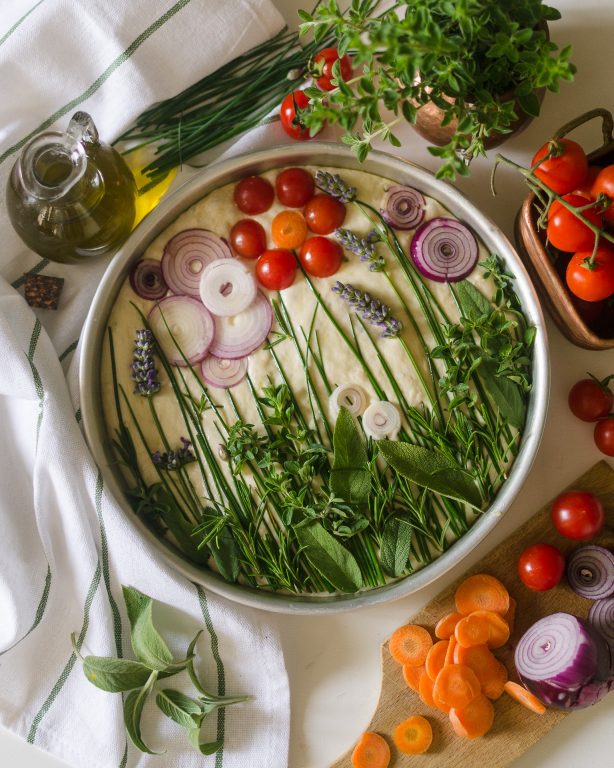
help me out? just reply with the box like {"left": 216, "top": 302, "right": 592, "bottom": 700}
{"left": 410, "top": 216, "right": 479, "bottom": 283}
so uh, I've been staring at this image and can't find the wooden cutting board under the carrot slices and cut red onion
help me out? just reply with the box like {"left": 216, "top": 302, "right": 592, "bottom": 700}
{"left": 331, "top": 461, "right": 614, "bottom": 768}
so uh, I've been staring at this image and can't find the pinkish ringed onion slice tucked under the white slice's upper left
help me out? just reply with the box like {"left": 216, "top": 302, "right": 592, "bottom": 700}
{"left": 161, "top": 228, "right": 233, "bottom": 298}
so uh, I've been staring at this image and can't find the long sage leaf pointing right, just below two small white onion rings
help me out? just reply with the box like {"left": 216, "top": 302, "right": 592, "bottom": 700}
{"left": 376, "top": 440, "right": 482, "bottom": 509}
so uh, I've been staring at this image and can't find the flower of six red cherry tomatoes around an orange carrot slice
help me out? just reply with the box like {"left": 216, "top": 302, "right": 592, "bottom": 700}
{"left": 229, "top": 168, "right": 345, "bottom": 291}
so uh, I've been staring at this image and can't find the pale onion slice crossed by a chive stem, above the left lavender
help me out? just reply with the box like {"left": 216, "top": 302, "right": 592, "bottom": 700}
{"left": 147, "top": 296, "right": 215, "bottom": 365}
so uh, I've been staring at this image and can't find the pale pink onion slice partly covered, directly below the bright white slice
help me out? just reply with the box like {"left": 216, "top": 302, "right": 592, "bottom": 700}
{"left": 209, "top": 291, "right": 273, "bottom": 360}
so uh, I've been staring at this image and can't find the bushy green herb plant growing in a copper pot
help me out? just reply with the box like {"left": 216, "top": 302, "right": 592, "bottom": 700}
{"left": 299, "top": 0, "right": 575, "bottom": 178}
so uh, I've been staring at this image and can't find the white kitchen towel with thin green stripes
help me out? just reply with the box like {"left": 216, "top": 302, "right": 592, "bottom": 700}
{"left": 0, "top": 0, "right": 289, "bottom": 768}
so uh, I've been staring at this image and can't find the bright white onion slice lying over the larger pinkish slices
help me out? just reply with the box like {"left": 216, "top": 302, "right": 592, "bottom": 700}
{"left": 200, "top": 259, "right": 257, "bottom": 317}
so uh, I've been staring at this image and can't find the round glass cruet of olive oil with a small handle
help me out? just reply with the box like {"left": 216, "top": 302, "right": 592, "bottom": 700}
{"left": 7, "top": 112, "right": 137, "bottom": 263}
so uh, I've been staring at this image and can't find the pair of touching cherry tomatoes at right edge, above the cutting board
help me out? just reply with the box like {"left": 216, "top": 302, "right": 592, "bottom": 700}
{"left": 568, "top": 374, "right": 614, "bottom": 456}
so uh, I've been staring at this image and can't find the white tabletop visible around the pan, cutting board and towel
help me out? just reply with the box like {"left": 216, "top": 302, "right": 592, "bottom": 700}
{"left": 0, "top": 0, "right": 614, "bottom": 768}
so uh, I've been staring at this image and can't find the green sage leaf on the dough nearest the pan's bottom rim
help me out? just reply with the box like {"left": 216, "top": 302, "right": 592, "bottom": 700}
{"left": 294, "top": 522, "right": 362, "bottom": 592}
